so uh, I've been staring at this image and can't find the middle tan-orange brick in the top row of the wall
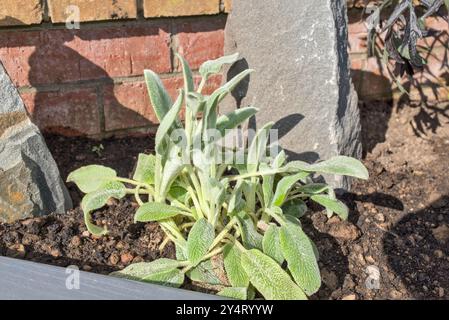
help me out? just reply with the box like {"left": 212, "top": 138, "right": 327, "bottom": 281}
{"left": 48, "top": 0, "right": 137, "bottom": 23}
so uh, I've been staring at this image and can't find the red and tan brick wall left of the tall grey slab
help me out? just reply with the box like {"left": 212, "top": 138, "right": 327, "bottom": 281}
{"left": 0, "top": 0, "right": 229, "bottom": 137}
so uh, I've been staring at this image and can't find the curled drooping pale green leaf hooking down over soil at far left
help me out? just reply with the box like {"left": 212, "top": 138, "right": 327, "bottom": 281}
{"left": 81, "top": 181, "right": 126, "bottom": 235}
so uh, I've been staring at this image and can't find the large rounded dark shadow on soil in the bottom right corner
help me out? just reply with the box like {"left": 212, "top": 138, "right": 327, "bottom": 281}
{"left": 383, "top": 196, "right": 449, "bottom": 299}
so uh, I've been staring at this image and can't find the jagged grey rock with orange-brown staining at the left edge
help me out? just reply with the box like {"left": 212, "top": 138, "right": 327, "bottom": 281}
{"left": 0, "top": 63, "right": 72, "bottom": 222}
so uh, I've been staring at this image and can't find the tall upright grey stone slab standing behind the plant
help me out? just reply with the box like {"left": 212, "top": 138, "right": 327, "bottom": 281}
{"left": 221, "top": 0, "right": 362, "bottom": 188}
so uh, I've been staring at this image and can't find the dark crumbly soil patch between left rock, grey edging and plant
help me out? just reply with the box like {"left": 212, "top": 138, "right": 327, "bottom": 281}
{"left": 0, "top": 201, "right": 175, "bottom": 274}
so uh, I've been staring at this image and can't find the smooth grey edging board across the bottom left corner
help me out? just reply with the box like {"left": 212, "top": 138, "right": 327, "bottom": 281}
{"left": 0, "top": 257, "right": 221, "bottom": 300}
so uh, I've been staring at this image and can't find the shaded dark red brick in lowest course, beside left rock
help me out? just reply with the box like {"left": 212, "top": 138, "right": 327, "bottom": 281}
{"left": 21, "top": 88, "right": 100, "bottom": 136}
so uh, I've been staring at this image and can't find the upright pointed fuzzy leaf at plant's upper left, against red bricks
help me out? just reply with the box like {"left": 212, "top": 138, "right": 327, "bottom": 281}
{"left": 144, "top": 70, "right": 173, "bottom": 121}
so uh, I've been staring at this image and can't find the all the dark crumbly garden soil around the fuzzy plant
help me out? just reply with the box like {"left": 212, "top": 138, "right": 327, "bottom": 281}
{"left": 0, "top": 102, "right": 449, "bottom": 300}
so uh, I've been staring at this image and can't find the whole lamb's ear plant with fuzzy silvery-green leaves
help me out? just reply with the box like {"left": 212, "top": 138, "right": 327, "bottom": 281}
{"left": 68, "top": 54, "right": 368, "bottom": 299}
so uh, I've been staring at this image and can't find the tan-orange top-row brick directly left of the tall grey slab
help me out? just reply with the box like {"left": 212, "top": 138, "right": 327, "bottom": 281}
{"left": 144, "top": 0, "right": 220, "bottom": 18}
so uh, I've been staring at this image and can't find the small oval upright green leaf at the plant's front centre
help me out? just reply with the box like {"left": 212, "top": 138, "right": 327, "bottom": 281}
{"left": 187, "top": 219, "right": 215, "bottom": 265}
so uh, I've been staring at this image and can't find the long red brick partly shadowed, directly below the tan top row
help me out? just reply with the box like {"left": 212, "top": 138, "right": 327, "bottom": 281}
{"left": 0, "top": 21, "right": 171, "bottom": 86}
